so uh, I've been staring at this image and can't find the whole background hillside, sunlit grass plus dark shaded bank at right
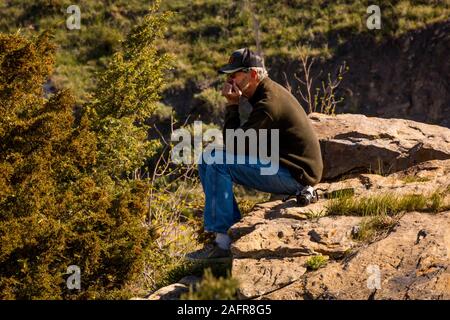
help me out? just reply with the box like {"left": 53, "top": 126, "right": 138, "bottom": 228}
{"left": 0, "top": 0, "right": 450, "bottom": 126}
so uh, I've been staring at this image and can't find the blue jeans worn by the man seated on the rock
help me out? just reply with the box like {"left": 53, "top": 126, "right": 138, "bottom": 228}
{"left": 198, "top": 151, "right": 303, "bottom": 233}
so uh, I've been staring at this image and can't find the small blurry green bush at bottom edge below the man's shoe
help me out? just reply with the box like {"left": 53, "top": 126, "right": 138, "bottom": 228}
{"left": 181, "top": 268, "right": 239, "bottom": 300}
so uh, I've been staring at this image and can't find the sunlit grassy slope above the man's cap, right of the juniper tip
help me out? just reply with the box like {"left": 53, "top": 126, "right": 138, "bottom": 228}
{"left": 160, "top": 0, "right": 450, "bottom": 86}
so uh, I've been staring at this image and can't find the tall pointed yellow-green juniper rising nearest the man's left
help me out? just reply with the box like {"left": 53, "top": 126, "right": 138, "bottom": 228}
{"left": 88, "top": 4, "right": 170, "bottom": 177}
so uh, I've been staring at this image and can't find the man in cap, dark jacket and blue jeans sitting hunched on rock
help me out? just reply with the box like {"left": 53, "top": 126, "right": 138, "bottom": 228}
{"left": 187, "top": 48, "right": 323, "bottom": 261}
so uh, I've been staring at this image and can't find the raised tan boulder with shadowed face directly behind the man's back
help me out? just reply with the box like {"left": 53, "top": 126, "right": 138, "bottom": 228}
{"left": 309, "top": 113, "right": 450, "bottom": 180}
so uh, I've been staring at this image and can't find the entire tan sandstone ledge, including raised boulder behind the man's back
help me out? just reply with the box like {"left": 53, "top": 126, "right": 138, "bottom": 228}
{"left": 148, "top": 114, "right": 450, "bottom": 299}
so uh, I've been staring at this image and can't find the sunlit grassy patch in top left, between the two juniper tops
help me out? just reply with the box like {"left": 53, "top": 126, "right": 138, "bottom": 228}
{"left": 0, "top": 0, "right": 148, "bottom": 101}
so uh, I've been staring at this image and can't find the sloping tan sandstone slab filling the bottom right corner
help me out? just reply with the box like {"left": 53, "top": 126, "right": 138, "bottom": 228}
{"left": 261, "top": 211, "right": 450, "bottom": 300}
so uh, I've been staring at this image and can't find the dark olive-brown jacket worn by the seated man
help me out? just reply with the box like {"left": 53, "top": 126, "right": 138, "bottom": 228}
{"left": 223, "top": 77, "right": 323, "bottom": 186}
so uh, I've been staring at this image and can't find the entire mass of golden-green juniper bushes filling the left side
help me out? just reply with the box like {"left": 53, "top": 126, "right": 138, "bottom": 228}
{"left": 0, "top": 1, "right": 172, "bottom": 299}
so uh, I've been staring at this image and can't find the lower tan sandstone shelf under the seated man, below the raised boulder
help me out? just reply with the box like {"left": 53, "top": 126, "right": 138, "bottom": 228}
{"left": 234, "top": 160, "right": 450, "bottom": 300}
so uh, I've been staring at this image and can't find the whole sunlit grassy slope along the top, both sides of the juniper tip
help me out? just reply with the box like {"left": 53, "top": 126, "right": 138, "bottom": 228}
{"left": 0, "top": 0, "right": 450, "bottom": 101}
